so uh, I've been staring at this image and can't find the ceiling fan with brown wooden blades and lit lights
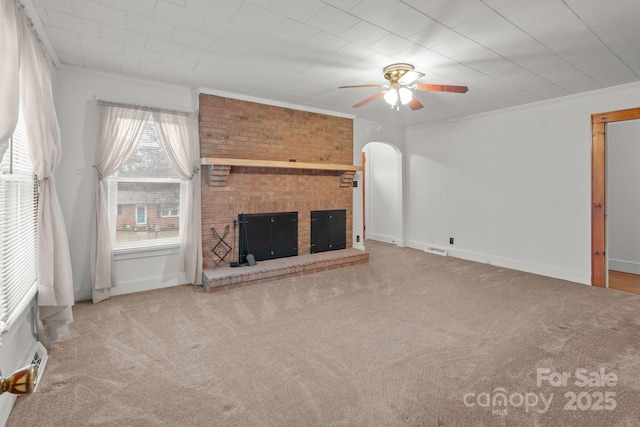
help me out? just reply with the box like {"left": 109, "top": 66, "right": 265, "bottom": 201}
{"left": 339, "top": 63, "right": 469, "bottom": 110}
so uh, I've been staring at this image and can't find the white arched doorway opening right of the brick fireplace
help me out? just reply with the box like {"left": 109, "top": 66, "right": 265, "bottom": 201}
{"left": 362, "top": 142, "right": 404, "bottom": 246}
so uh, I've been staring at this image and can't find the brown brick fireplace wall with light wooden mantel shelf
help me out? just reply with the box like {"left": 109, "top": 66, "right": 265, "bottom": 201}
{"left": 200, "top": 94, "right": 368, "bottom": 290}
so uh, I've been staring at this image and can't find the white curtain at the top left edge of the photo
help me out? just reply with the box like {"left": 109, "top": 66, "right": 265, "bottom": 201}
{"left": 0, "top": 0, "right": 20, "bottom": 159}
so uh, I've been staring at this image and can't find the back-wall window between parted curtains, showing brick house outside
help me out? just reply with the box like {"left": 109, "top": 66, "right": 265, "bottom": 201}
{"left": 105, "top": 120, "right": 186, "bottom": 250}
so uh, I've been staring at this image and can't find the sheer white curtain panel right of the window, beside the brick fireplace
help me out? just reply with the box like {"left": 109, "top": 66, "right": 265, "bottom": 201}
{"left": 152, "top": 111, "right": 202, "bottom": 284}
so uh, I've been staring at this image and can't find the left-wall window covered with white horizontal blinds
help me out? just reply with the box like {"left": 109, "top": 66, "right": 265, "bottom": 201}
{"left": 0, "top": 103, "right": 38, "bottom": 333}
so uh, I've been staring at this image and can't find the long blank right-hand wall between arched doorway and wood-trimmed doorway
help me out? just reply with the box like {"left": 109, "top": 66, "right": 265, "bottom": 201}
{"left": 405, "top": 84, "right": 640, "bottom": 284}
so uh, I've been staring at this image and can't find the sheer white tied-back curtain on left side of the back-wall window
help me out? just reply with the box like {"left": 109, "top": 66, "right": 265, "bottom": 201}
{"left": 91, "top": 103, "right": 151, "bottom": 303}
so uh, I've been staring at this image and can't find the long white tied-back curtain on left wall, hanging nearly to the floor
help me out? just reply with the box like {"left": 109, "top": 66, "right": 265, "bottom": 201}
{"left": 16, "top": 0, "right": 74, "bottom": 347}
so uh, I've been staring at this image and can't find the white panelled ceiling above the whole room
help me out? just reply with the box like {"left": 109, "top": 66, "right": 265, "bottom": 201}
{"left": 25, "top": 0, "right": 640, "bottom": 126}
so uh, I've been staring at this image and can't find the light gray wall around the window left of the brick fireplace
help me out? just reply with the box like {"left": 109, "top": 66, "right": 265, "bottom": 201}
{"left": 55, "top": 67, "right": 197, "bottom": 301}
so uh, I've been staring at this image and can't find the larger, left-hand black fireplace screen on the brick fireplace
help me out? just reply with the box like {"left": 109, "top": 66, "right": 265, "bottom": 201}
{"left": 238, "top": 212, "right": 298, "bottom": 264}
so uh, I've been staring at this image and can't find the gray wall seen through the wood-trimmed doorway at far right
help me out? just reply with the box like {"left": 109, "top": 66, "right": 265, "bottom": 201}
{"left": 606, "top": 120, "right": 640, "bottom": 274}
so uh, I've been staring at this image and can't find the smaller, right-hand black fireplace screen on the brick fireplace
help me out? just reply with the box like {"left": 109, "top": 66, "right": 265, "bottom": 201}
{"left": 311, "top": 209, "right": 347, "bottom": 254}
